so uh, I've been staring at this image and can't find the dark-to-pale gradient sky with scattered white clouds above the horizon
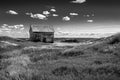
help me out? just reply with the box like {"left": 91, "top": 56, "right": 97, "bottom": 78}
{"left": 0, "top": 0, "right": 120, "bottom": 38}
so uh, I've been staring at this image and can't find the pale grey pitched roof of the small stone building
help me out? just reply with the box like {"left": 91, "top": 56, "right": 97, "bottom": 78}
{"left": 31, "top": 25, "right": 54, "bottom": 32}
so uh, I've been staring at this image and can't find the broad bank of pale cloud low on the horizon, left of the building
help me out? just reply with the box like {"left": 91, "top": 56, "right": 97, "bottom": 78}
{"left": 0, "top": 24, "right": 28, "bottom": 38}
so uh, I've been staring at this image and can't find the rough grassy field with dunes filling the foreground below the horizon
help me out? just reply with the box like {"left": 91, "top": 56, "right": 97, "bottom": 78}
{"left": 0, "top": 34, "right": 120, "bottom": 80}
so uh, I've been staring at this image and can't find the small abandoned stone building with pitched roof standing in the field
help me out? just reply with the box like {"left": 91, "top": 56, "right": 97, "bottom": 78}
{"left": 29, "top": 25, "right": 54, "bottom": 43}
